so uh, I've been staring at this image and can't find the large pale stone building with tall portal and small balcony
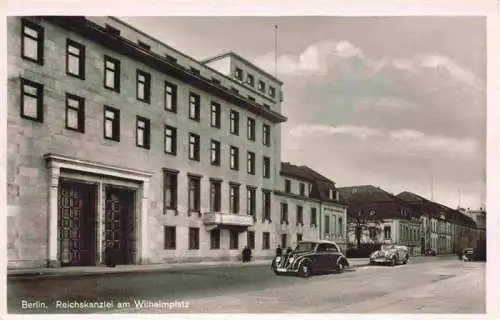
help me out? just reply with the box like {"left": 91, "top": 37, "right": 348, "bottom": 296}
{"left": 7, "top": 17, "right": 286, "bottom": 267}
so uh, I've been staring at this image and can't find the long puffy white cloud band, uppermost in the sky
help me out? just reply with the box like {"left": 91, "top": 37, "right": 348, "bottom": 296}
{"left": 254, "top": 40, "right": 482, "bottom": 88}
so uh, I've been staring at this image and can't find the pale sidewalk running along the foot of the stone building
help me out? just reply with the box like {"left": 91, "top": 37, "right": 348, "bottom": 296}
{"left": 7, "top": 258, "right": 368, "bottom": 279}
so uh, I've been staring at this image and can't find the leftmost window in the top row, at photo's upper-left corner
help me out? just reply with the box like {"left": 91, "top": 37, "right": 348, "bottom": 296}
{"left": 21, "top": 19, "right": 44, "bottom": 65}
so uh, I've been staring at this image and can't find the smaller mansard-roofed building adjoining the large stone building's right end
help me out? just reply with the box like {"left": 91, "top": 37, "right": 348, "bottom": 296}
{"left": 274, "top": 162, "right": 346, "bottom": 250}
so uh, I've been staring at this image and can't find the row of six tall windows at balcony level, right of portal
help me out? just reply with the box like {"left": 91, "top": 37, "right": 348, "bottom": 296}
{"left": 163, "top": 169, "right": 271, "bottom": 221}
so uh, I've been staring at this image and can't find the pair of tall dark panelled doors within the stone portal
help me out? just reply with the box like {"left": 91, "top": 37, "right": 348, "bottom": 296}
{"left": 58, "top": 179, "right": 137, "bottom": 266}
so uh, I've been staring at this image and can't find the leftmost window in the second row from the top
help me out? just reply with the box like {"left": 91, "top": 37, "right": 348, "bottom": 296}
{"left": 21, "top": 79, "right": 43, "bottom": 122}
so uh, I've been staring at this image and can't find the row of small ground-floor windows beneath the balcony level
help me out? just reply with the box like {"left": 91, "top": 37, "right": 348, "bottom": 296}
{"left": 164, "top": 226, "right": 271, "bottom": 250}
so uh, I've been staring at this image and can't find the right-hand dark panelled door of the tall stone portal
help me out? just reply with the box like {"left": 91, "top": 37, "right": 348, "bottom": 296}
{"left": 103, "top": 186, "right": 137, "bottom": 264}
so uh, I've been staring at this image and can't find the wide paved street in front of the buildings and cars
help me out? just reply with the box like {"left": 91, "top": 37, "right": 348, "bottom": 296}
{"left": 7, "top": 257, "right": 486, "bottom": 313}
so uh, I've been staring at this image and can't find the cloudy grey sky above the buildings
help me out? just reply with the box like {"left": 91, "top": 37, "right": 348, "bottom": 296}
{"left": 120, "top": 16, "right": 486, "bottom": 208}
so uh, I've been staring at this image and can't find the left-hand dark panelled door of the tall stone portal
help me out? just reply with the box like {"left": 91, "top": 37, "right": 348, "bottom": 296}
{"left": 58, "top": 181, "right": 97, "bottom": 266}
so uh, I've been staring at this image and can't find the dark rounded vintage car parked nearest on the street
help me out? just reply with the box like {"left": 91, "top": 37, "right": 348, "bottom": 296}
{"left": 272, "top": 240, "right": 349, "bottom": 277}
